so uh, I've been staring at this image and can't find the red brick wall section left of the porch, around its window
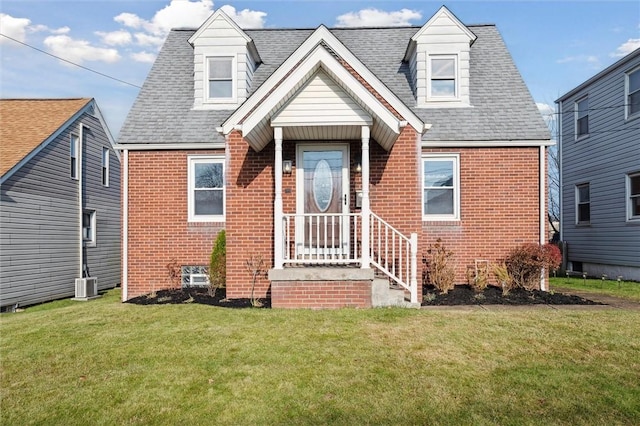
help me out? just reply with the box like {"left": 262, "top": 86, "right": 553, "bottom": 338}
{"left": 123, "top": 151, "right": 224, "bottom": 298}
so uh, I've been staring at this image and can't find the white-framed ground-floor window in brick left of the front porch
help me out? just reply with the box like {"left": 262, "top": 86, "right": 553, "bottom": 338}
{"left": 188, "top": 156, "right": 225, "bottom": 222}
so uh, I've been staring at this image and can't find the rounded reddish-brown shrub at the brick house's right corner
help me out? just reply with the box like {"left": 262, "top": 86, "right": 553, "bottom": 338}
{"left": 505, "top": 244, "right": 562, "bottom": 290}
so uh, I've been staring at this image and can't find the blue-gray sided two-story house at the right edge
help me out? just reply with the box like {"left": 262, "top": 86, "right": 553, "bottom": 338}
{"left": 556, "top": 49, "right": 640, "bottom": 281}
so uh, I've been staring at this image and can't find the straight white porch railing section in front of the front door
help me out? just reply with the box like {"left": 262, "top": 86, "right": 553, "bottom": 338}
{"left": 283, "top": 213, "right": 360, "bottom": 264}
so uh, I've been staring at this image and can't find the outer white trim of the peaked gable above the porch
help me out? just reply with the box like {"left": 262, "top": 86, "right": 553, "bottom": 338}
{"left": 222, "top": 25, "right": 424, "bottom": 138}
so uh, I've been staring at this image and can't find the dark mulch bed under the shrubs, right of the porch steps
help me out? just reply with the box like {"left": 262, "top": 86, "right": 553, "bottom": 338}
{"left": 422, "top": 285, "right": 602, "bottom": 306}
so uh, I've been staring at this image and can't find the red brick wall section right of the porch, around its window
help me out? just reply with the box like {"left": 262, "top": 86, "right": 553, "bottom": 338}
{"left": 418, "top": 147, "right": 540, "bottom": 283}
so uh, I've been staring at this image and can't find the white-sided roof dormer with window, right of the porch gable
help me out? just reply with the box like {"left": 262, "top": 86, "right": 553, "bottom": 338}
{"left": 404, "top": 6, "right": 476, "bottom": 108}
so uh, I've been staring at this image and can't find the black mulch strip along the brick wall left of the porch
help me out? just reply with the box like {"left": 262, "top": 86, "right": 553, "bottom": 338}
{"left": 126, "top": 287, "right": 271, "bottom": 308}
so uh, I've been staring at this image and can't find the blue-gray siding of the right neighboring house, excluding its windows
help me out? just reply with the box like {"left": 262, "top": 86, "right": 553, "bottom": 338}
{"left": 560, "top": 50, "right": 640, "bottom": 267}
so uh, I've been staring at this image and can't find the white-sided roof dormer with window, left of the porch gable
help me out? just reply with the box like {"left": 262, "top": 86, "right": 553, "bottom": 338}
{"left": 189, "top": 9, "right": 260, "bottom": 109}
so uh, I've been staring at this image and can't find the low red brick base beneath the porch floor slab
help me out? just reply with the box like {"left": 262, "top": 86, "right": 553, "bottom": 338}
{"left": 271, "top": 280, "right": 371, "bottom": 309}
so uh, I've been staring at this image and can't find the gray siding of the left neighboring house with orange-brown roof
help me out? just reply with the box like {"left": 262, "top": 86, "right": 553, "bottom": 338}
{"left": 0, "top": 114, "right": 120, "bottom": 306}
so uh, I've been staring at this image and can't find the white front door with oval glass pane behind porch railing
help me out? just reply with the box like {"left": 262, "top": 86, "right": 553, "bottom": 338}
{"left": 296, "top": 144, "right": 350, "bottom": 260}
